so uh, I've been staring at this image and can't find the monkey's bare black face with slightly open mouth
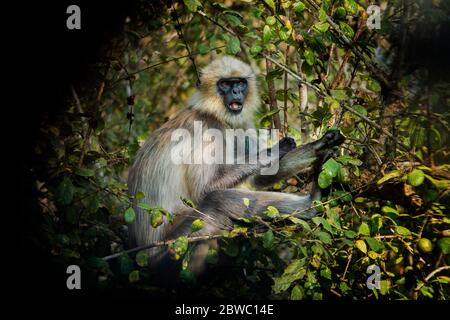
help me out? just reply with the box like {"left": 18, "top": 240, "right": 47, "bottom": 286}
{"left": 217, "top": 78, "right": 248, "bottom": 114}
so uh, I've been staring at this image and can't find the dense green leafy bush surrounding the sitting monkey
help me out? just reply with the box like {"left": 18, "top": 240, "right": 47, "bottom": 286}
{"left": 29, "top": 0, "right": 450, "bottom": 299}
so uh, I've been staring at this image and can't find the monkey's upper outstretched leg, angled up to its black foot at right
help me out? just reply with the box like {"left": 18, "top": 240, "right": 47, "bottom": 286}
{"left": 251, "top": 130, "right": 345, "bottom": 187}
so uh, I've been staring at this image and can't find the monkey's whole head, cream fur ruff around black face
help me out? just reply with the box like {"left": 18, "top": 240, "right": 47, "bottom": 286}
{"left": 192, "top": 56, "right": 259, "bottom": 128}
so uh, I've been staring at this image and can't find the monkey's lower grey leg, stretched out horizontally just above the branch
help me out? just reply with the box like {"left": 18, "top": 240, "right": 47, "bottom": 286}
{"left": 162, "top": 189, "right": 320, "bottom": 275}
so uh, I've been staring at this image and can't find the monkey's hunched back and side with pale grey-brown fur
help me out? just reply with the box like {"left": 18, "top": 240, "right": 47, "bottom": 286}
{"left": 128, "top": 108, "right": 224, "bottom": 254}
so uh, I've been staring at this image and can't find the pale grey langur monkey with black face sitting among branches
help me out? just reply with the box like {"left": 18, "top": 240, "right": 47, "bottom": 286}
{"left": 128, "top": 56, "right": 344, "bottom": 273}
